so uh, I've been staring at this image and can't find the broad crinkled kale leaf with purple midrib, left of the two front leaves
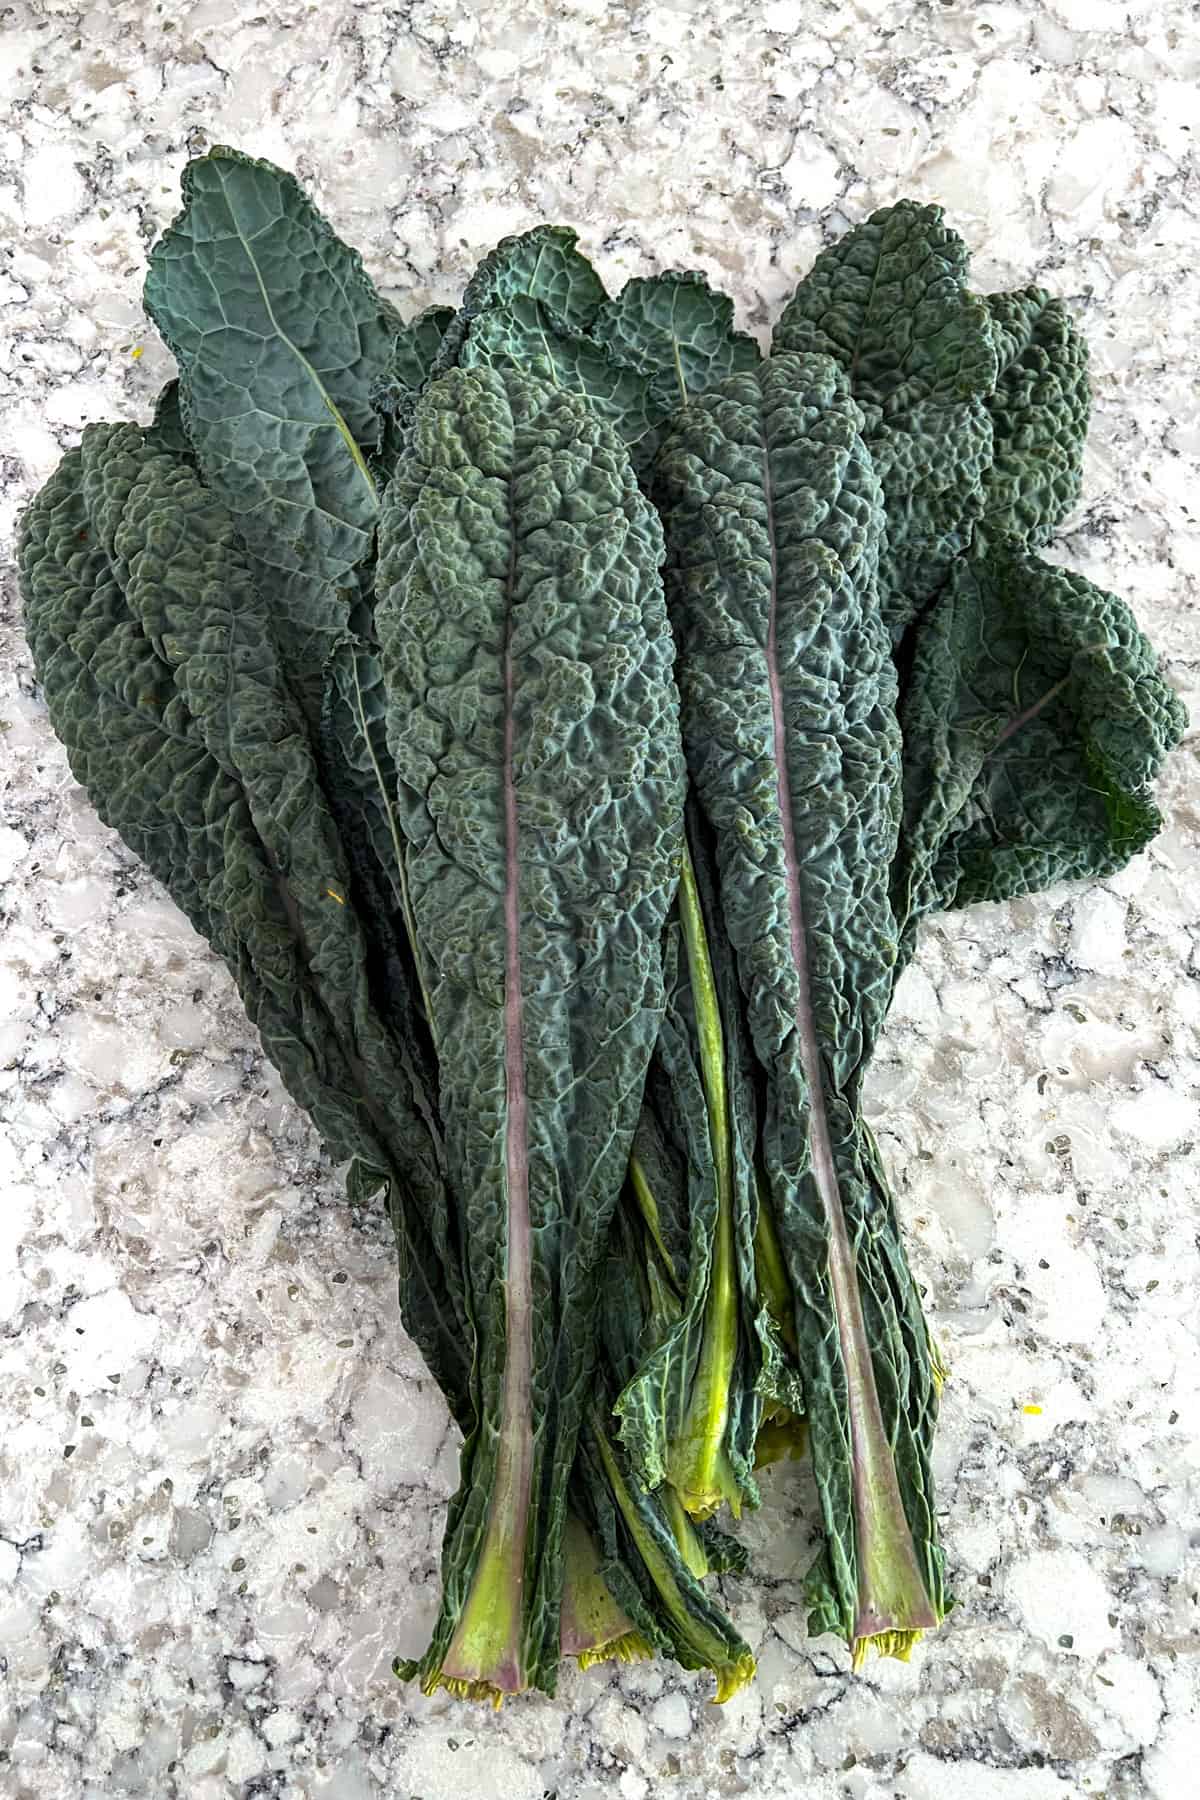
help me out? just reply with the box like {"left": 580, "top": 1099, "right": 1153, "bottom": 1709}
{"left": 376, "top": 369, "right": 682, "bottom": 1692}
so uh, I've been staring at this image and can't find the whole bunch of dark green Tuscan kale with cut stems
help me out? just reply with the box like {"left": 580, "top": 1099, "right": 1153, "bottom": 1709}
{"left": 22, "top": 149, "right": 1182, "bottom": 1697}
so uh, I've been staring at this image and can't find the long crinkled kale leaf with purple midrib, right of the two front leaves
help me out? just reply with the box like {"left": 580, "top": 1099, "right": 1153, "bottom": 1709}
{"left": 657, "top": 355, "right": 943, "bottom": 1645}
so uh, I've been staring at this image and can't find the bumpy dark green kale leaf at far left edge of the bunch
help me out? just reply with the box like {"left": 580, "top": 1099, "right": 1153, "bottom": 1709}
{"left": 20, "top": 425, "right": 471, "bottom": 1429}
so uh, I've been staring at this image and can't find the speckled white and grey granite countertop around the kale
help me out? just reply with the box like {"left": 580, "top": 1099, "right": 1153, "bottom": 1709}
{"left": 0, "top": 0, "right": 1200, "bottom": 1800}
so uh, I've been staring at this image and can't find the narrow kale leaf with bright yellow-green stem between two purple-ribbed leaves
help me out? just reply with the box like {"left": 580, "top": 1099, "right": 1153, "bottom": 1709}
{"left": 615, "top": 781, "right": 806, "bottom": 1540}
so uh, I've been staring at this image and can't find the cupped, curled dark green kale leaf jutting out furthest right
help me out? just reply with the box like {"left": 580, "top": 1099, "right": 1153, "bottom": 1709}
{"left": 892, "top": 542, "right": 1186, "bottom": 959}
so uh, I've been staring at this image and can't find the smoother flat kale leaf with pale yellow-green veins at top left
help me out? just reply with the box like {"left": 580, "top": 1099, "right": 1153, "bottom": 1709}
{"left": 146, "top": 146, "right": 399, "bottom": 702}
